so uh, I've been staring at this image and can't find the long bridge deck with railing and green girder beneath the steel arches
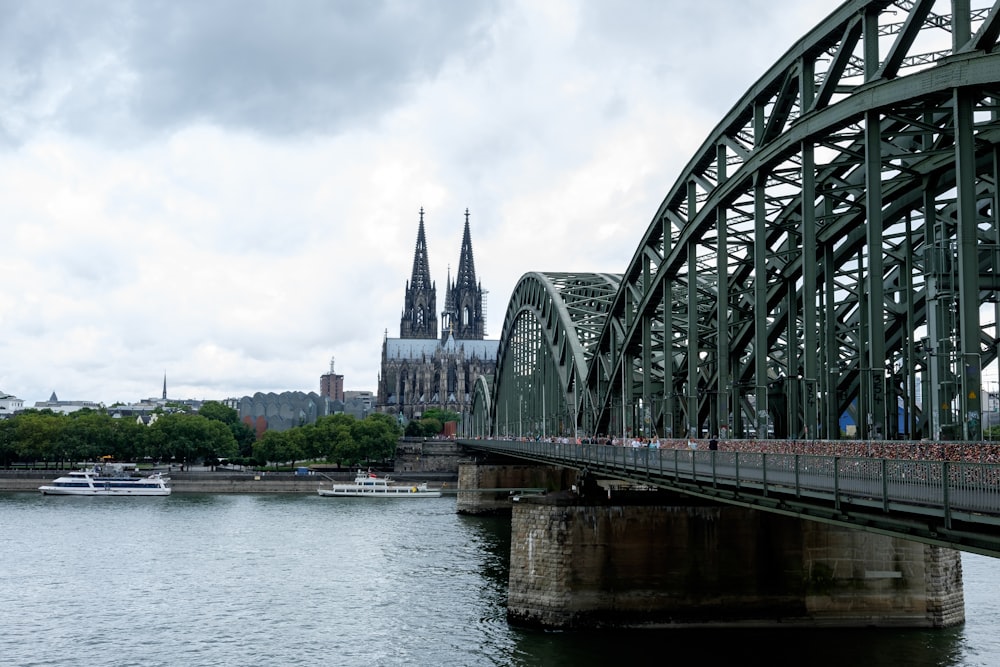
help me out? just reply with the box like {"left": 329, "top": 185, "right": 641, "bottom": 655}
{"left": 462, "top": 440, "right": 1000, "bottom": 558}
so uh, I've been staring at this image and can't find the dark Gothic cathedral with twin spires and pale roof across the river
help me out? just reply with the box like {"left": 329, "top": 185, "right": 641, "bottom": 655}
{"left": 376, "top": 208, "right": 499, "bottom": 422}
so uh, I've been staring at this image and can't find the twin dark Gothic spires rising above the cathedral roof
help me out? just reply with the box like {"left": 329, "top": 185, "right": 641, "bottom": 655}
{"left": 399, "top": 208, "right": 486, "bottom": 340}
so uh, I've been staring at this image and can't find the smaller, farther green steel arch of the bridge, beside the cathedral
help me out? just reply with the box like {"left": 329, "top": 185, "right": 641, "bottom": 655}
{"left": 490, "top": 273, "right": 621, "bottom": 437}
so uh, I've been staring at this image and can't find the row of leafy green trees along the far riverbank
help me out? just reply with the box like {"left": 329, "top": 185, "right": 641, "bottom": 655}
{"left": 0, "top": 401, "right": 402, "bottom": 467}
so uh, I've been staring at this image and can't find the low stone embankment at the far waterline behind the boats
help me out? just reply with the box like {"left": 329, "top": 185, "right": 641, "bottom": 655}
{"left": 0, "top": 470, "right": 458, "bottom": 493}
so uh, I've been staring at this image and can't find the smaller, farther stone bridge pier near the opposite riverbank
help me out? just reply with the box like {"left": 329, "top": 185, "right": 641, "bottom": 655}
{"left": 455, "top": 462, "right": 576, "bottom": 514}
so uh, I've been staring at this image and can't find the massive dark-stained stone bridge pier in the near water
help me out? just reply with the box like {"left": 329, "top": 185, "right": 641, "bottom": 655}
{"left": 507, "top": 493, "right": 965, "bottom": 628}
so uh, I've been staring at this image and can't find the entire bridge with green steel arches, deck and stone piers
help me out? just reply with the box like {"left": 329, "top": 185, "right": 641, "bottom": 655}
{"left": 459, "top": 0, "right": 1000, "bottom": 626}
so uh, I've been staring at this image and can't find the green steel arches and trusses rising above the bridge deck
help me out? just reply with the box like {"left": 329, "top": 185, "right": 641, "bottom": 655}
{"left": 478, "top": 0, "right": 1000, "bottom": 440}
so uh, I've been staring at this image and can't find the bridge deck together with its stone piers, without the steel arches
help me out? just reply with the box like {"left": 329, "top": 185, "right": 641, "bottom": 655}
{"left": 458, "top": 439, "right": 988, "bottom": 628}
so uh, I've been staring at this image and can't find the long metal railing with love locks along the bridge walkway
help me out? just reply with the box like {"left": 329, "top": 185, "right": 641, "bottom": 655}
{"left": 468, "top": 441, "right": 1000, "bottom": 524}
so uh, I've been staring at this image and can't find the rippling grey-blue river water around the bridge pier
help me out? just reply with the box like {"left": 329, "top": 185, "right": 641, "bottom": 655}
{"left": 0, "top": 493, "right": 1000, "bottom": 667}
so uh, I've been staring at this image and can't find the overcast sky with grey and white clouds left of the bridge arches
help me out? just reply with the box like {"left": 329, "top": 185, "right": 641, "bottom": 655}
{"left": 0, "top": 0, "right": 834, "bottom": 405}
